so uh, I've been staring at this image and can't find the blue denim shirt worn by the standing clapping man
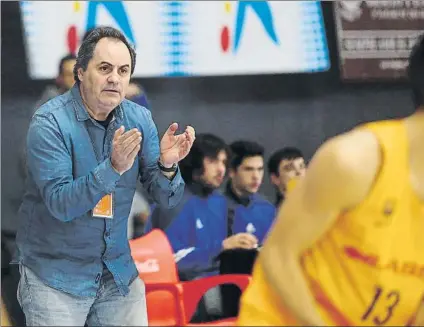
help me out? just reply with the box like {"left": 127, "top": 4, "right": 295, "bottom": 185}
{"left": 14, "top": 84, "right": 184, "bottom": 296}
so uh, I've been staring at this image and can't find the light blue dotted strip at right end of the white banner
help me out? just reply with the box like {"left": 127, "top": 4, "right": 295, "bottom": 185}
{"left": 301, "top": 1, "right": 330, "bottom": 72}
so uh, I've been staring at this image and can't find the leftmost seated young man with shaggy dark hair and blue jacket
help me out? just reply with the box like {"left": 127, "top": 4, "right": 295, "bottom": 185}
{"left": 165, "top": 134, "right": 258, "bottom": 280}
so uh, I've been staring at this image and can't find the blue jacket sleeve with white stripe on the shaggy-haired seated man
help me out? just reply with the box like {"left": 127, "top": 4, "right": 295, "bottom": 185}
{"left": 165, "top": 205, "right": 222, "bottom": 272}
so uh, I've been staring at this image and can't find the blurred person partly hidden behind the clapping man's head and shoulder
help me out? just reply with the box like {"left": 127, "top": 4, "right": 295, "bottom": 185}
{"left": 33, "top": 54, "right": 77, "bottom": 111}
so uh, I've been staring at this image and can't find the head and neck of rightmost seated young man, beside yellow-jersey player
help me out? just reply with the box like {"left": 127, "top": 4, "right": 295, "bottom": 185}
{"left": 268, "top": 147, "right": 306, "bottom": 207}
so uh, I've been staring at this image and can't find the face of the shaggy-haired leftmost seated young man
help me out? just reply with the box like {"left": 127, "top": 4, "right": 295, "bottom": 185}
{"left": 200, "top": 150, "right": 227, "bottom": 188}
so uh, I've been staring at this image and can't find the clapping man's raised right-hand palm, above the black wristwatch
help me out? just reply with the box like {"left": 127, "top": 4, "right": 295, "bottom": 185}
{"left": 160, "top": 123, "right": 196, "bottom": 168}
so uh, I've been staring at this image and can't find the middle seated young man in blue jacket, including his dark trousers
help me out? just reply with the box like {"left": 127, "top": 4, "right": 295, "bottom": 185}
{"left": 220, "top": 141, "right": 276, "bottom": 317}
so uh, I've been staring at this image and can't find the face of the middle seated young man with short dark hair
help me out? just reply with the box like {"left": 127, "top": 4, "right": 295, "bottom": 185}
{"left": 230, "top": 156, "right": 264, "bottom": 194}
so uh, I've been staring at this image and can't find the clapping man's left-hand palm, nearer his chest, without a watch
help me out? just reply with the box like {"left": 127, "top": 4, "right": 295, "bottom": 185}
{"left": 110, "top": 126, "right": 142, "bottom": 175}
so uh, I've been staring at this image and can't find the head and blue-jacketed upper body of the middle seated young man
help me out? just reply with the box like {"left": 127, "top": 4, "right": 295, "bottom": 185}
{"left": 225, "top": 141, "right": 275, "bottom": 243}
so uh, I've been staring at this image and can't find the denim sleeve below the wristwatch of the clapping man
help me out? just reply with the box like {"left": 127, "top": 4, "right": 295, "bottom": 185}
{"left": 139, "top": 111, "right": 184, "bottom": 208}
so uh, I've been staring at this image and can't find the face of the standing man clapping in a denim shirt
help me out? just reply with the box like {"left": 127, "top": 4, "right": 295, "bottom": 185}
{"left": 78, "top": 38, "right": 131, "bottom": 109}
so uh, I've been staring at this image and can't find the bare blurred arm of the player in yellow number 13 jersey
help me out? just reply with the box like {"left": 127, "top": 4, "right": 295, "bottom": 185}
{"left": 260, "top": 131, "right": 380, "bottom": 326}
